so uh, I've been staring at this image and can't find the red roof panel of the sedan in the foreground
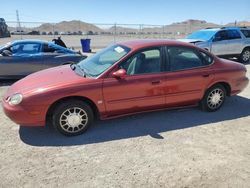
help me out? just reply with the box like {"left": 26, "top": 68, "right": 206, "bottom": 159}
{"left": 118, "top": 39, "right": 198, "bottom": 50}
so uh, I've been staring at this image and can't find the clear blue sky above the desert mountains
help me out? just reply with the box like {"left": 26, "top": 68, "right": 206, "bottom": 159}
{"left": 0, "top": 0, "right": 250, "bottom": 25}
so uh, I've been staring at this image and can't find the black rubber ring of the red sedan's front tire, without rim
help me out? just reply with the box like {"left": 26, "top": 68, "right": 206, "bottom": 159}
{"left": 52, "top": 100, "right": 94, "bottom": 136}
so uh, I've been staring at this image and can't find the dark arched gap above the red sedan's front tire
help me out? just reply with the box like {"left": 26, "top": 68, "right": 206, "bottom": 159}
{"left": 46, "top": 96, "right": 100, "bottom": 122}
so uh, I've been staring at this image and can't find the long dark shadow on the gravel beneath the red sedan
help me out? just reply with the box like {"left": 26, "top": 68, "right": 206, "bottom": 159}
{"left": 19, "top": 96, "right": 250, "bottom": 147}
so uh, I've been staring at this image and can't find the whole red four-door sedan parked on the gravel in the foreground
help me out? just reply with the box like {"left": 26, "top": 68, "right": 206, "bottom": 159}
{"left": 2, "top": 40, "right": 249, "bottom": 136}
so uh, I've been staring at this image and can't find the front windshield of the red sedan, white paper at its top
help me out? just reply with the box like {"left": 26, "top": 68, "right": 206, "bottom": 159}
{"left": 78, "top": 45, "right": 130, "bottom": 77}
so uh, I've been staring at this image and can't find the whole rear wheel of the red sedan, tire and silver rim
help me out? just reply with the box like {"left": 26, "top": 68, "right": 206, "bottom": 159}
{"left": 200, "top": 84, "right": 226, "bottom": 112}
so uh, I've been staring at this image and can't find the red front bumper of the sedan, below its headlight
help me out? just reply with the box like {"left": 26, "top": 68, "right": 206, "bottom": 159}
{"left": 2, "top": 100, "right": 47, "bottom": 127}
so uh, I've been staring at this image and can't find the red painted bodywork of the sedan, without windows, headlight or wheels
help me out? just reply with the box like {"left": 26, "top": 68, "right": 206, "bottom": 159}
{"left": 2, "top": 40, "right": 248, "bottom": 126}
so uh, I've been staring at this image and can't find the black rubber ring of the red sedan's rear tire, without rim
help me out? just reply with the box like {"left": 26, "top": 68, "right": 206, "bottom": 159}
{"left": 201, "top": 84, "right": 226, "bottom": 112}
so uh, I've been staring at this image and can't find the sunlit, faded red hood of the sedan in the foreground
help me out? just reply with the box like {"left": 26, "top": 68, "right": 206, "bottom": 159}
{"left": 5, "top": 65, "right": 91, "bottom": 97}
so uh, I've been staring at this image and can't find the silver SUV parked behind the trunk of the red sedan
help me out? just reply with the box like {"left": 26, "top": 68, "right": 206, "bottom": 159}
{"left": 180, "top": 27, "right": 250, "bottom": 63}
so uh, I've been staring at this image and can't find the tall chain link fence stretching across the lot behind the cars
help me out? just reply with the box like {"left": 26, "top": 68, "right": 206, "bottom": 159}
{"left": 0, "top": 21, "right": 215, "bottom": 49}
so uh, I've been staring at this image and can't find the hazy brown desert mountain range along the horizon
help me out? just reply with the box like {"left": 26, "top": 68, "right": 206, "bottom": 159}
{"left": 6, "top": 19, "right": 250, "bottom": 34}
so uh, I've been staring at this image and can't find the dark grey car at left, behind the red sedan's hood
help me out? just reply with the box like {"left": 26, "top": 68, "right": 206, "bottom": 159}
{"left": 0, "top": 40, "right": 86, "bottom": 79}
